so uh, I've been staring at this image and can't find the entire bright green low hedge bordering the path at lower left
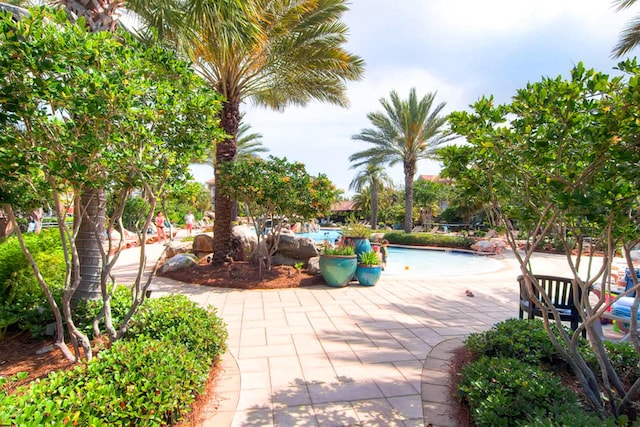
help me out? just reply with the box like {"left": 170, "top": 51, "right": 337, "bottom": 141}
{"left": 0, "top": 296, "right": 227, "bottom": 426}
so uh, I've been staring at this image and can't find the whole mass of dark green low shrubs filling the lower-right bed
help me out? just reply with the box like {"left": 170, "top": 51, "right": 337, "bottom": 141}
{"left": 457, "top": 319, "right": 624, "bottom": 427}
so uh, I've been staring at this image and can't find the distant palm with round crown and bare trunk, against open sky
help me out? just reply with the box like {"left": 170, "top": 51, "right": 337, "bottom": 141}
{"left": 349, "top": 88, "right": 450, "bottom": 233}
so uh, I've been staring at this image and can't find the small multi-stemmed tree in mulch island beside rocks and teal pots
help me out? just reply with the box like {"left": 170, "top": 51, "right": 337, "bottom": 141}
{"left": 219, "top": 156, "right": 338, "bottom": 269}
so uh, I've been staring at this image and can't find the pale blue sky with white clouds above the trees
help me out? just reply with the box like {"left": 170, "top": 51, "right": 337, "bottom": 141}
{"left": 189, "top": 0, "right": 640, "bottom": 196}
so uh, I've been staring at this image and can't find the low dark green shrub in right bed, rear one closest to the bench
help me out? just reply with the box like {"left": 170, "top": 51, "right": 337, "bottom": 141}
{"left": 465, "top": 319, "right": 562, "bottom": 365}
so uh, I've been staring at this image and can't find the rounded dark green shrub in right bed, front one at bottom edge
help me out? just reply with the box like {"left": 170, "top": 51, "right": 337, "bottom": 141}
{"left": 458, "top": 356, "right": 578, "bottom": 427}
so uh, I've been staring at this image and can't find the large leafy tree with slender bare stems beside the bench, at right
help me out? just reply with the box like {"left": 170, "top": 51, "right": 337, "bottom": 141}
{"left": 443, "top": 61, "right": 640, "bottom": 416}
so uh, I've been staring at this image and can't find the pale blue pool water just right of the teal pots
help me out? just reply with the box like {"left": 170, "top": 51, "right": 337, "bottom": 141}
{"left": 383, "top": 247, "right": 502, "bottom": 277}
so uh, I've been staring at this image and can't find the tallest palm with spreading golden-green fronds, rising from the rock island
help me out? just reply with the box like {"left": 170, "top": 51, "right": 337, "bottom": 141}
{"left": 162, "top": 0, "right": 363, "bottom": 262}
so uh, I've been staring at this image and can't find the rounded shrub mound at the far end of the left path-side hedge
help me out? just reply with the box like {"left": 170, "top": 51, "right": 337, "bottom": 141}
{"left": 129, "top": 295, "right": 227, "bottom": 360}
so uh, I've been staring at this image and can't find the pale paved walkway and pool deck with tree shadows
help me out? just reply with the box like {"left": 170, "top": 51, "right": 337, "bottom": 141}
{"left": 115, "top": 236, "right": 604, "bottom": 427}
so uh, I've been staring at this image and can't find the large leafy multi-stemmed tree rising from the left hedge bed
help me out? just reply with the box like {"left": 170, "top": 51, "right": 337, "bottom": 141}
{"left": 0, "top": 9, "right": 225, "bottom": 359}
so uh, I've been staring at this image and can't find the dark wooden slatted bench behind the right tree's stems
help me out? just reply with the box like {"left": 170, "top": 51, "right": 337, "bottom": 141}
{"left": 518, "top": 275, "right": 586, "bottom": 335}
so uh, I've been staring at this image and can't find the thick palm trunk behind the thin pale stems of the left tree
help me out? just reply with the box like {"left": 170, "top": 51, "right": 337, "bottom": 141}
{"left": 73, "top": 188, "right": 106, "bottom": 301}
